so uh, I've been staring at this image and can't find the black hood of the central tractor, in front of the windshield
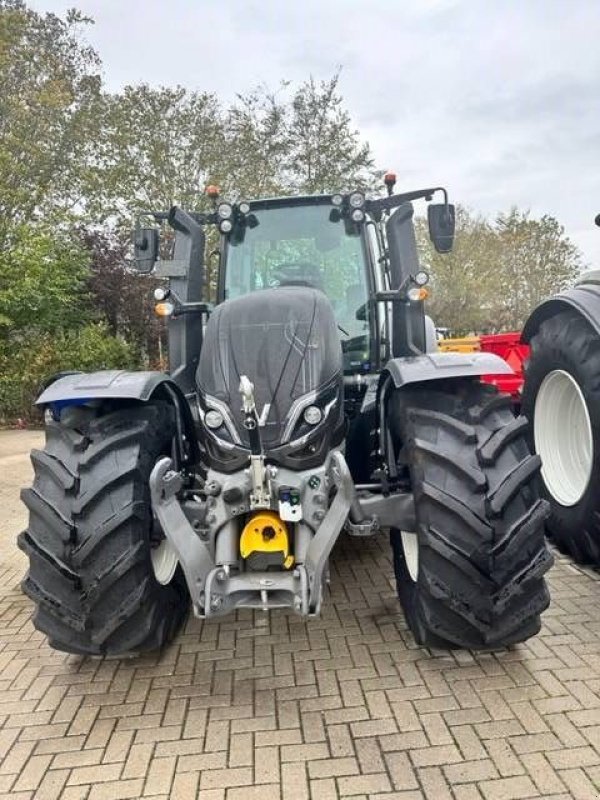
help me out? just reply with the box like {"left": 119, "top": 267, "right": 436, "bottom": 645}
{"left": 197, "top": 286, "right": 343, "bottom": 452}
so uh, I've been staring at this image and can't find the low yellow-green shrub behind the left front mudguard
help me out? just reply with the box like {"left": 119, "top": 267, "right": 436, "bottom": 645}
{"left": 0, "top": 323, "right": 138, "bottom": 423}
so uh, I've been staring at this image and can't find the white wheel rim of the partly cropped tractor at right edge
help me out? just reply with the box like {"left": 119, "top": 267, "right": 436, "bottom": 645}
{"left": 533, "top": 369, "right": 594, "bottom": 506}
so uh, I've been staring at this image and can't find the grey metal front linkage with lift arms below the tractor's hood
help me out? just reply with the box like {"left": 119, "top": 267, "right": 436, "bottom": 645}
{"left": 150, "top": 376, "right": 414, "bottom": 617}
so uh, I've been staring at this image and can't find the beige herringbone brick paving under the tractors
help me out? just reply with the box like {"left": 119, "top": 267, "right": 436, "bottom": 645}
{"left": 0, "top": 438, "right": 600, "bottom": 800}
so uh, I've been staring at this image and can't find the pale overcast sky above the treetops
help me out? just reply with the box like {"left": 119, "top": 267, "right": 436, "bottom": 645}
{"left": 30, "top": 0, "right": 600, "bottom": 267}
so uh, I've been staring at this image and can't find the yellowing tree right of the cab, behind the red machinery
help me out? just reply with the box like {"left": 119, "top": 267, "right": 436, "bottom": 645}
{"left": 417, "top": 207, "right": 581, "bottom": 336}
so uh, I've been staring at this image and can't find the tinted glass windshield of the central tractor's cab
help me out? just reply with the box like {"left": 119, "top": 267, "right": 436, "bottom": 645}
{"left": 225, "top": 204, "right": 370, "bottom": 372}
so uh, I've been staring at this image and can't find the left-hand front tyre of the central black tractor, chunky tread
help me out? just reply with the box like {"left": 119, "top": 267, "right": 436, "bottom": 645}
{"left": 18, "top": 402, "right": 189, "bottom": 656}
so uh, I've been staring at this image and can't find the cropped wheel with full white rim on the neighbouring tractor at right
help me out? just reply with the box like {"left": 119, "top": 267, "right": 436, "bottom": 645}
{"left": 522, "top": 311, "right": 600, "bottom": 565}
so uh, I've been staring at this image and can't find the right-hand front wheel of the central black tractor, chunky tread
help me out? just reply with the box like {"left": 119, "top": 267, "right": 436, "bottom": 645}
{"left": 388, "top": 380, "right": 552, "bottom": 650}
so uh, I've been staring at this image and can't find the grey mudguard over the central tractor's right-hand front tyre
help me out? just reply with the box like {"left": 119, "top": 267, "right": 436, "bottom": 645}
{"left": 381, "top": 353, "right": 514, "bottom": 389}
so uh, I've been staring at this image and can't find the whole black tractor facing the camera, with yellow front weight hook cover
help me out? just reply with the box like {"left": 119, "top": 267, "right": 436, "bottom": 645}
{"left": 19, "top": 175, "right": 552, "bottom": 656}
